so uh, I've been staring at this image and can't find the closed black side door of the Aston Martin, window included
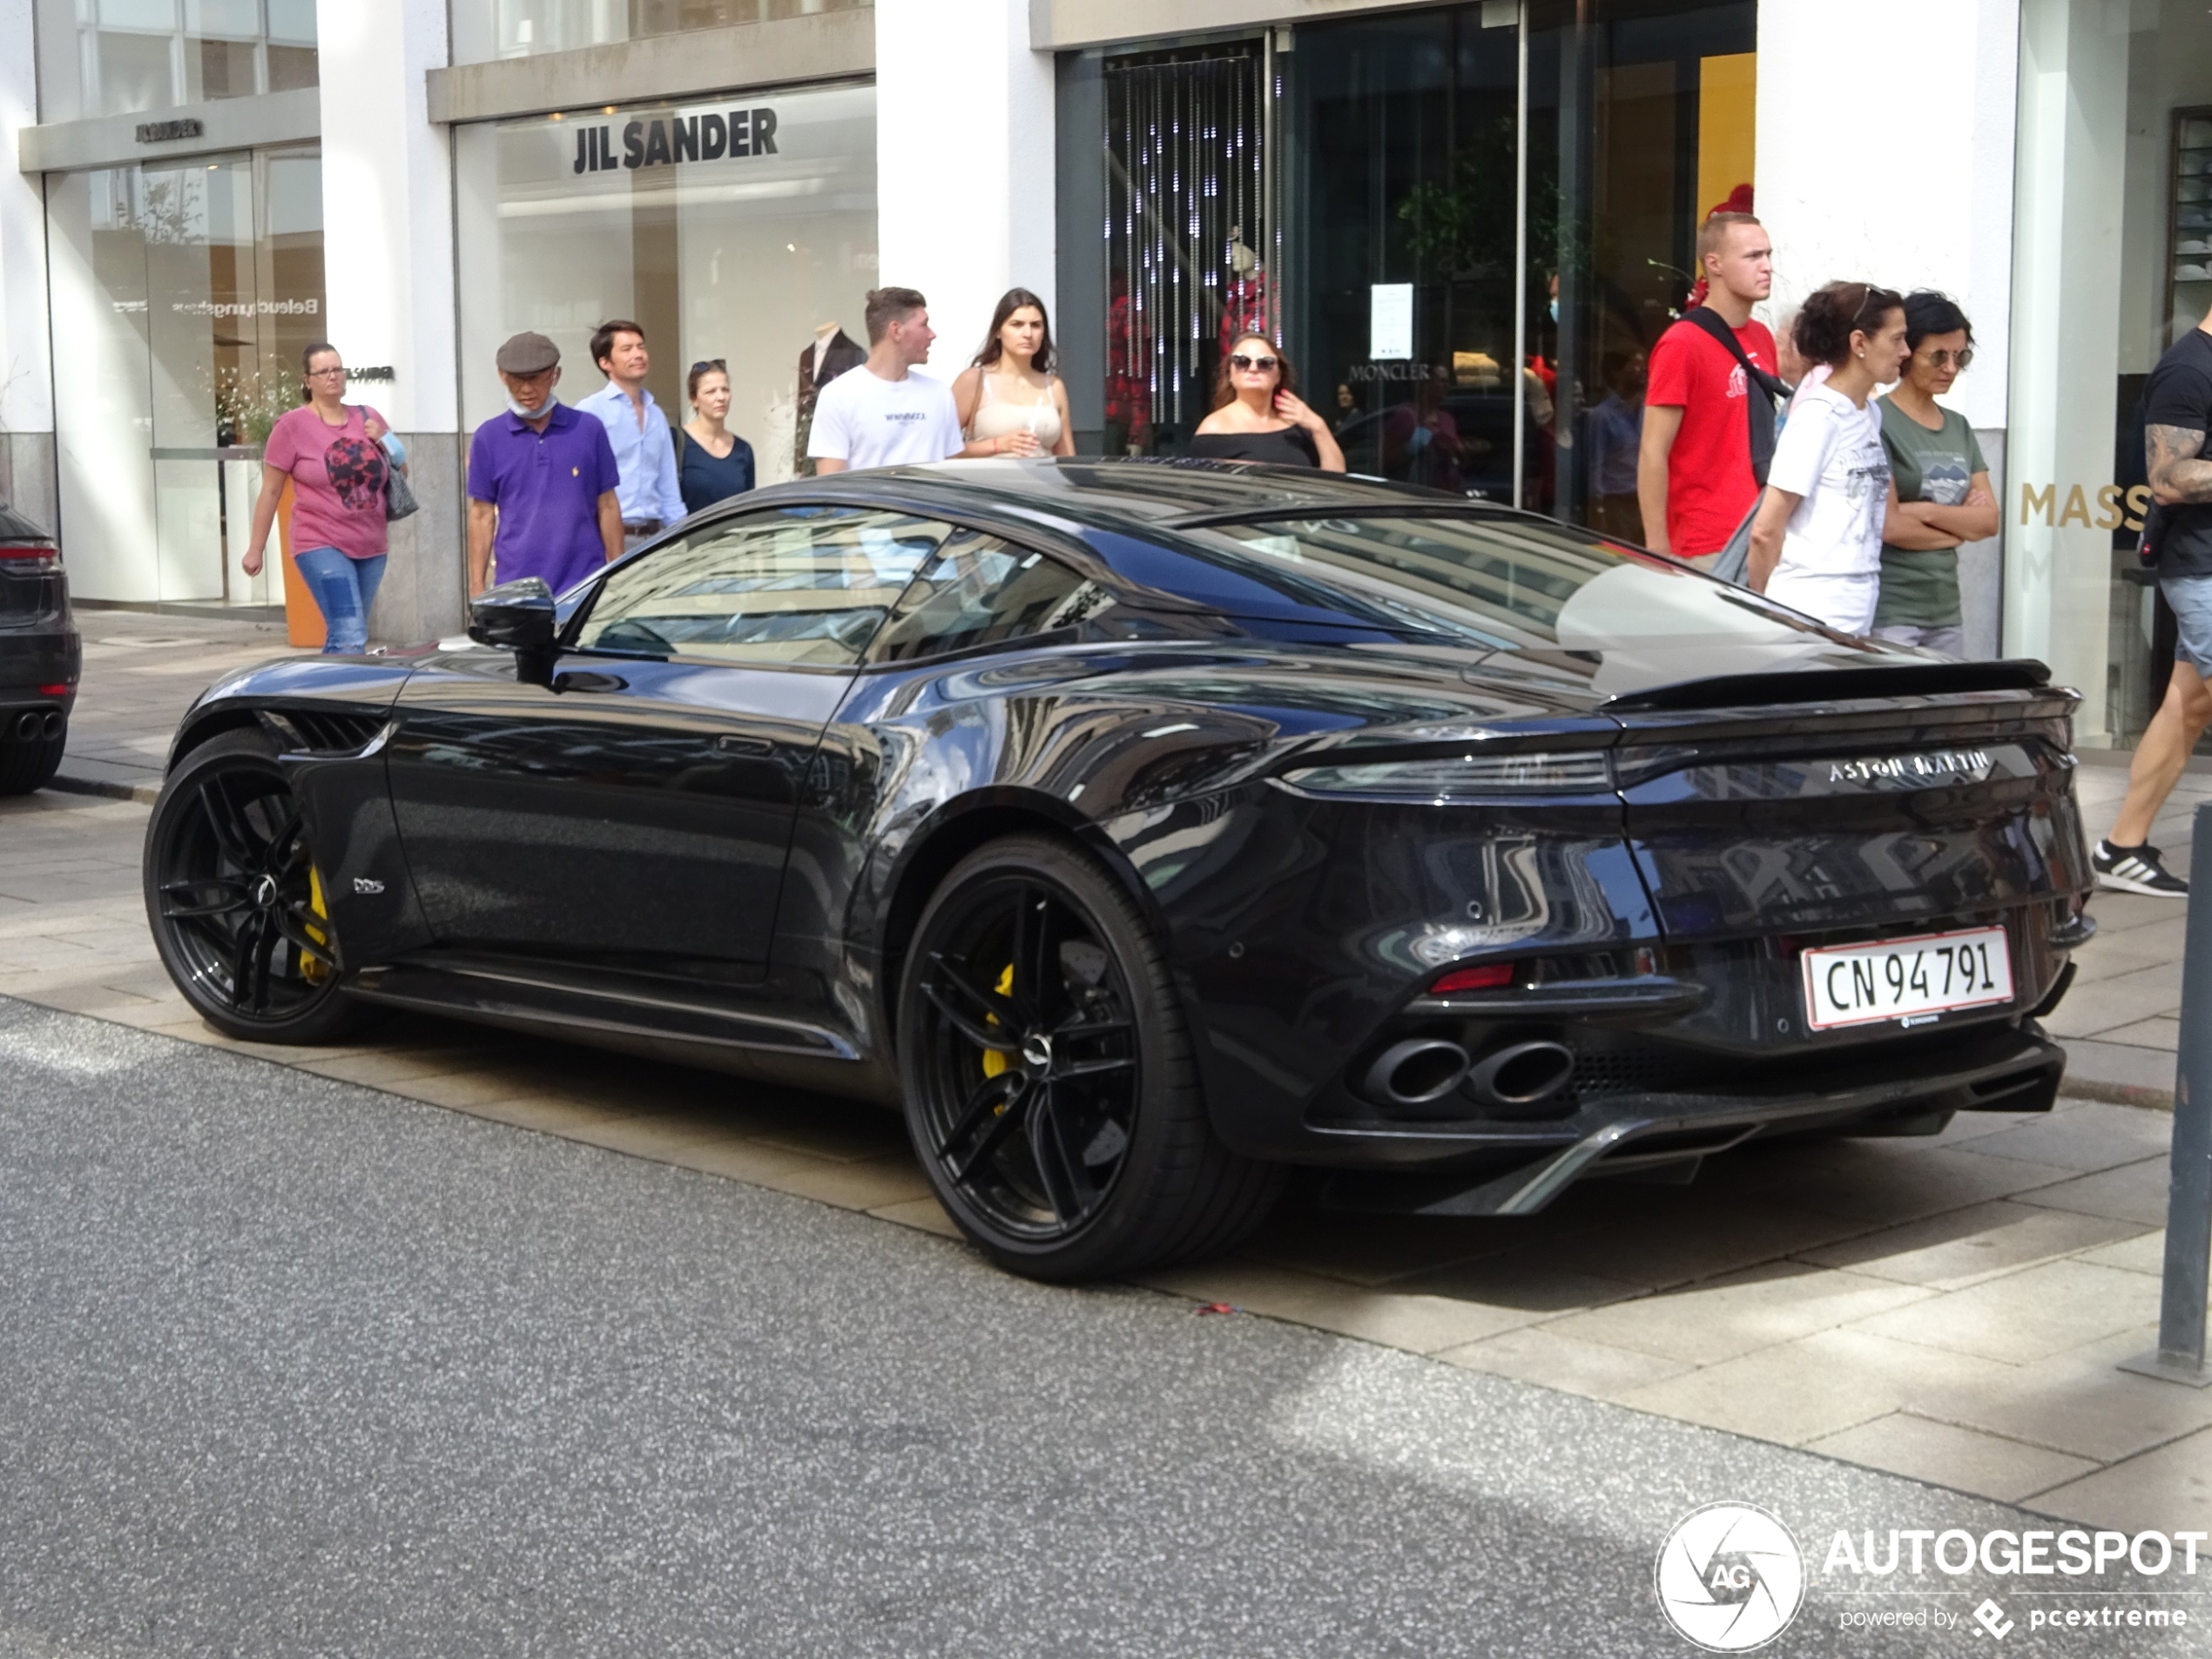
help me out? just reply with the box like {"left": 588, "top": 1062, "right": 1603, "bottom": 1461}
{"left": 388, "top": 507, "right": 949, "bottom": 978}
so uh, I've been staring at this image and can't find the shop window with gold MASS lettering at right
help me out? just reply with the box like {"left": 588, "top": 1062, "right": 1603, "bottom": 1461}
{"left": 2004, "top": 0, "right": 2212, "bottom": 748}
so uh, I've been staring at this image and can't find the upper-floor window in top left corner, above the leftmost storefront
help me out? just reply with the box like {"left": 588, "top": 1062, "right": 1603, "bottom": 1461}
{"left": 36, "top": 0, "right": 316, "bottom": 122}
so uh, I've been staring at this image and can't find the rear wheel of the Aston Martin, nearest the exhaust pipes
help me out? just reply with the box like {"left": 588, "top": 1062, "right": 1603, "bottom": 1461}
{"left": 898, "top": 834, "right": 1283, "bottom": 1281}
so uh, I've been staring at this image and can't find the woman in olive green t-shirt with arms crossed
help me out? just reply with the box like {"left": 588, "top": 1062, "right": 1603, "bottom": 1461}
{"left": 1873, "top": 290, "right": 1998, "bottom": 657}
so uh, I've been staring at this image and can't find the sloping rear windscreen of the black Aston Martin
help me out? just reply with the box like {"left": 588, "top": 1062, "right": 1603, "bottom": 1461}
{"left": 1192, "top": 516, "right": 1887, "bottom": 692}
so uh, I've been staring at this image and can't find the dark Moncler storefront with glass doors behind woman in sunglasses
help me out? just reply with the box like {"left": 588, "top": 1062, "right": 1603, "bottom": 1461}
{"left": 1060, "top": 0, "right": 1757, "bottom": 540}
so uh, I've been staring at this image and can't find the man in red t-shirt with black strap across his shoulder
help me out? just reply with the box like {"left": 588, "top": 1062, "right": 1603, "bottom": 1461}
{"left": 1637, "top": 212, "right": 1774, "bottom": 557}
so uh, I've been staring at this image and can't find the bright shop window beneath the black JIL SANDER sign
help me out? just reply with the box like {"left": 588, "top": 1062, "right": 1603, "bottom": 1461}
{"left": 454, "top": 86, "right": 876, "bottom": 484}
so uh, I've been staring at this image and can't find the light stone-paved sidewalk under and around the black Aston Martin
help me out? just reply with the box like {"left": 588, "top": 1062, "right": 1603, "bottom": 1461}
{"left": 17, "top": 613, "right": 2212, "bottom": 1531}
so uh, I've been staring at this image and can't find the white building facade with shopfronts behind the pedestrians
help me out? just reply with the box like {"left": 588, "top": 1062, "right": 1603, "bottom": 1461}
{"left": 0, "top": 0, "right": 2212, "bottom": 748}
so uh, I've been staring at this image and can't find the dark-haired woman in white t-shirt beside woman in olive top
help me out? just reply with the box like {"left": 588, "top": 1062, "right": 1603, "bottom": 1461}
{"left": 1745, "top": 283, "right": 1909, "bottom": 632}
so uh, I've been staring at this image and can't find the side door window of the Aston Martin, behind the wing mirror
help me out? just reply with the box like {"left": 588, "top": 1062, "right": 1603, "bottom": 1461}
{"left": 570, "top": 507, "right": 954, "bottom": 668}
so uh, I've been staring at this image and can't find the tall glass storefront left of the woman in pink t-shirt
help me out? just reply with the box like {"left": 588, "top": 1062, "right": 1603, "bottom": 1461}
{"left": 46, "top": 151, "right": 323, "bottom": 606}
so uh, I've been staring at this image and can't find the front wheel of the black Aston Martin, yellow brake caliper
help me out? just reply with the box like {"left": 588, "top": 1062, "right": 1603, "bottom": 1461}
{"left": 144, "top": 732, "right": 374, "bottom": 1044}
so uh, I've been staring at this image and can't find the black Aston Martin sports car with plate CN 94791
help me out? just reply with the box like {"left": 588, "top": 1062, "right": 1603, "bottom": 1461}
{"left": 146, "top": 460, "right": 2090, "bottom": 1278}
